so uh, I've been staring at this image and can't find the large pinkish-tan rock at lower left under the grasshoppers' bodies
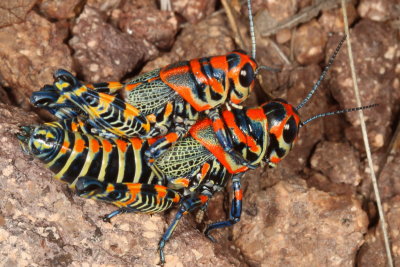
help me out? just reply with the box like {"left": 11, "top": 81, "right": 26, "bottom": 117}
{"left": 0, "top": 104, "right": 240, "bottom": 266}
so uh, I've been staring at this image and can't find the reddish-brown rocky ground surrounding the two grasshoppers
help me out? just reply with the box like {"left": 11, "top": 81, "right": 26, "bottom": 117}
{"left": 0, "top": 0, "right": 400, "bottom": 266}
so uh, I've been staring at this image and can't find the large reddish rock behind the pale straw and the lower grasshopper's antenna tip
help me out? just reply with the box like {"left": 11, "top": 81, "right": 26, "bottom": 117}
{"left": 328, "top": 20, "right": 399, "bottom": 150}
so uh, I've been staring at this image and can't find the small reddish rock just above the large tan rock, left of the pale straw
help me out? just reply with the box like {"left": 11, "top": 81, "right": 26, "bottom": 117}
{"left": 311, "top": 142, "right": 362, "bottom": 186}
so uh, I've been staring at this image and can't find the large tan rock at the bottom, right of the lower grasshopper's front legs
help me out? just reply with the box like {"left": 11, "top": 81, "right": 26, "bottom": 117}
{"left": 233, "top": 181, "right": 368, "bottom": 266}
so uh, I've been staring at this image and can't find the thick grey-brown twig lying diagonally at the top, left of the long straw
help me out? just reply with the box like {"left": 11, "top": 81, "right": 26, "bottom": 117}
{"left": 261, "top": 0, "right": 349, "bottom": 37}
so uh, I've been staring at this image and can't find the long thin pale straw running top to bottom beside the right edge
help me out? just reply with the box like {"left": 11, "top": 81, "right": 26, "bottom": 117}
{"left": 341, "top": 0, "right": 393, "bottom": 267}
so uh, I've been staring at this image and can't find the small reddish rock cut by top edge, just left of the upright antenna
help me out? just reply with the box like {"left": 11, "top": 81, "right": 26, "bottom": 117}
{"left": 171, "top": 0, "right": 216, "bottom": 24}
